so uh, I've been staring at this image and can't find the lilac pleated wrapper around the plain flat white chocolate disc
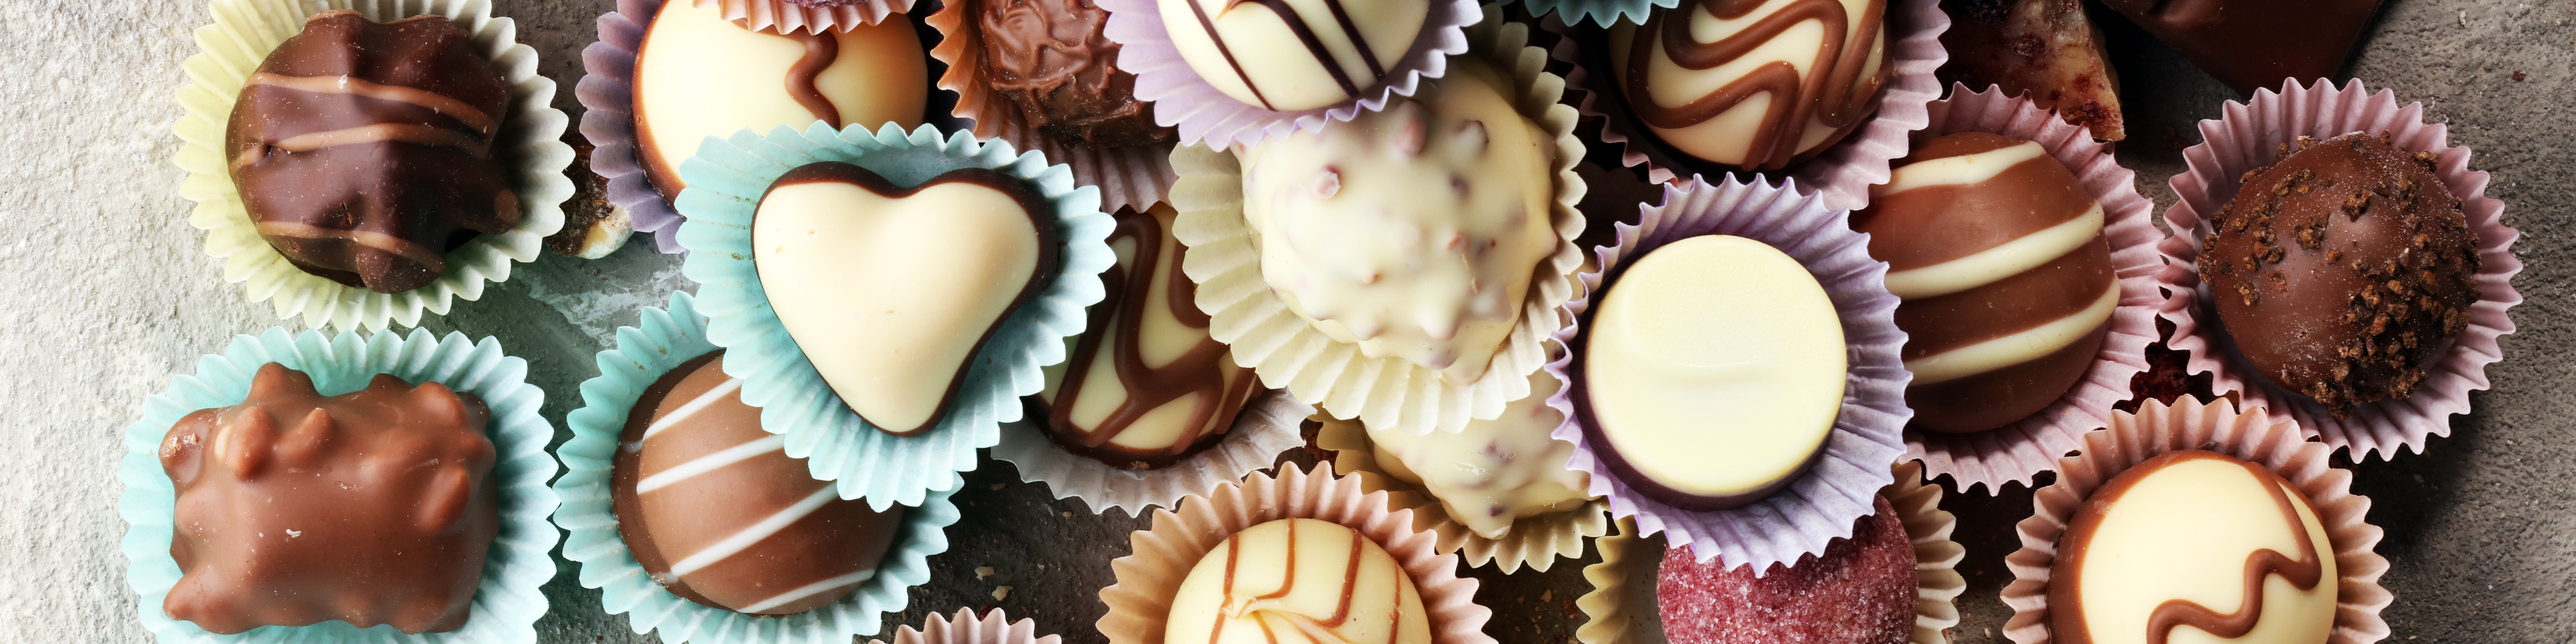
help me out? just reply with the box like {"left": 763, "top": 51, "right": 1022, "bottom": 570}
{"left": 1548, "top": 178, "right": 1914, "bottom": 572}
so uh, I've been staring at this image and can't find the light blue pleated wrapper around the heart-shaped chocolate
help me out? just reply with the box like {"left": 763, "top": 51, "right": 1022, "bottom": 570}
{"left": 680, "top": 123, "right": 1118, "bottom": 510}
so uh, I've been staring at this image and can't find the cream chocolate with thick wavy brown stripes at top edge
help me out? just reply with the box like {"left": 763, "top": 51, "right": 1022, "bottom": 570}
{"left": 1610, "top": 0, "right": 1888, "bottom": 170}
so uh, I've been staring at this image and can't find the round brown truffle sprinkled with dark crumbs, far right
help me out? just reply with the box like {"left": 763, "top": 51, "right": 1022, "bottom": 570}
{"left": 2200, "top": 131, "right": 2478, "bottom": 417}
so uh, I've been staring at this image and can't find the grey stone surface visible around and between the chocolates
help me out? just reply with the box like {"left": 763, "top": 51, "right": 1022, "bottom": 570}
{"left": 0, "top": 0, "right": 2576, "bottom": 644}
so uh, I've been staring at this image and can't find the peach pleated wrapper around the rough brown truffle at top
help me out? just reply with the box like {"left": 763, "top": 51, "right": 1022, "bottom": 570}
{"left": 922, "top": 3, "right": 1177, "bottom": 211}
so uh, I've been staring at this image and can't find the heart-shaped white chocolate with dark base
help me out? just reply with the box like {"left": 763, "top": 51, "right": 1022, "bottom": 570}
{"left": 752, "top": 162, "right": 1061, "bottom": 435}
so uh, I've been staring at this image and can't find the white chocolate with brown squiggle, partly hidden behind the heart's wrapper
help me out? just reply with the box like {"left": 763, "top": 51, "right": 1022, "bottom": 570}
{"left": 634, "top": 0, "right": 930, "bottom": 201}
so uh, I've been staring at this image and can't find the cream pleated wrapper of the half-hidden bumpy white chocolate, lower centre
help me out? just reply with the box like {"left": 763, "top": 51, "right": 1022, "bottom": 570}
{"left": 1313, "top": 412, "right": 1610, "bottom": 574}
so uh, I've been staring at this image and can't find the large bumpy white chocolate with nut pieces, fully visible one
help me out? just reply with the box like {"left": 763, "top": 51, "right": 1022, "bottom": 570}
{"left": 1239, "top": 56, "right": 1558, "bottom": 381}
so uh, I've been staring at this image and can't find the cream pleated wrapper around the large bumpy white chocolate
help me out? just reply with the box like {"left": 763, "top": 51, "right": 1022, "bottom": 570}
{"left": 1169, "top": 8, "right": 1585, "bottom": 435}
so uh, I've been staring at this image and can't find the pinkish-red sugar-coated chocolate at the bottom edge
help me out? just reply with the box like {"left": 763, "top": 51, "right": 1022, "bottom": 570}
{"left": 1654, "top": 497, "right": 1919, "bottom": 644}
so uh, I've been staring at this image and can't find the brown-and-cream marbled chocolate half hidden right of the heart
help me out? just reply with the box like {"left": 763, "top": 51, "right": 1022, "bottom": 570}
{"left": 1030, "top": 203, "right": 1254, "bottom": 469}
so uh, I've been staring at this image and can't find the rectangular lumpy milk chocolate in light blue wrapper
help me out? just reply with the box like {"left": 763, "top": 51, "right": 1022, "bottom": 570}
{"left": 160, "top": 363, "right": 500, "bottom": 634}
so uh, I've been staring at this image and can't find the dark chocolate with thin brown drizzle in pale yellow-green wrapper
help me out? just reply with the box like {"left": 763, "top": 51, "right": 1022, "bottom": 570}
{"left": 224, "top": 10, "right": 521, "bottom": 294}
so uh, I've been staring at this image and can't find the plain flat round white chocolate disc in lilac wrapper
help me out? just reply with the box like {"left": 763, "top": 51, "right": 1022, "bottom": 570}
{"left": 1574, "top": 234, "right": 1847, "bottom": 510}
